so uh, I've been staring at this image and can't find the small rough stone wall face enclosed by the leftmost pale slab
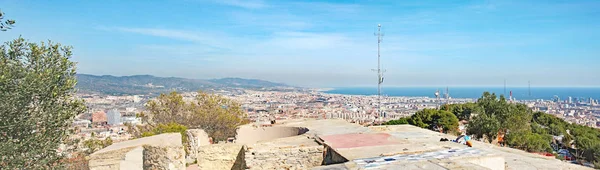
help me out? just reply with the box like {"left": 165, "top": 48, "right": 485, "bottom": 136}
{"left": 143, "top": 145, "right": 186, "bottom": 170}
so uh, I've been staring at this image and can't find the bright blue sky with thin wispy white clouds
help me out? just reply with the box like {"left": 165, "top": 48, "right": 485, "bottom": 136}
{"left": 0, "top": 0, "right": 600, "bottom": 87}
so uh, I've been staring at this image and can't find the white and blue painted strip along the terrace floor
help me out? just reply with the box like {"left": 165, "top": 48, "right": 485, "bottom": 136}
{"left": 354, "top": 148, "right": 484, "bottom": 169}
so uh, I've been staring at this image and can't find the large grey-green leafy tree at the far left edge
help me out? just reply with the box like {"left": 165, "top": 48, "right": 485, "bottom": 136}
{"left": 0, "top": 38, "right": 85, "bottom": 169}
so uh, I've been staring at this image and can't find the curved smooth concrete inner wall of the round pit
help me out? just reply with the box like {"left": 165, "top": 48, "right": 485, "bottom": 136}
{"left": 236, "top": 125, "right": 308, "bottom": 144}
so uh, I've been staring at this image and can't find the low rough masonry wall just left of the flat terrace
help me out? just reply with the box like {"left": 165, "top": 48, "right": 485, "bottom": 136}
{"left": 245, "top": 146, "right": 323, "bottom": 170}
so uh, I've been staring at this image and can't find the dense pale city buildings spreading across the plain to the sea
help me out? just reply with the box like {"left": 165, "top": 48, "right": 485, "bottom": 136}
{"left": 74, "top": 89, "right": 600, "bottom": 145}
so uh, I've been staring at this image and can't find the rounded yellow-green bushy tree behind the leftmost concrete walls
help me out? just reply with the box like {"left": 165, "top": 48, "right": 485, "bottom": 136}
{"left": 142, "top": 91, "right": 249, "bottom": 140}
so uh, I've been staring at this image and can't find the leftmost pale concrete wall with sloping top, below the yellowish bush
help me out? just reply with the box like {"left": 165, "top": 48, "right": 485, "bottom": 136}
{"left": 88, "top": 133, "right": 185, "bottom": 170}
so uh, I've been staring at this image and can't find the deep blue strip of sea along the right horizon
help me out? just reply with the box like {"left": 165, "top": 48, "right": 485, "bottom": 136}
{"left": 325, "top": 87, "right": 600, "bottom": 102}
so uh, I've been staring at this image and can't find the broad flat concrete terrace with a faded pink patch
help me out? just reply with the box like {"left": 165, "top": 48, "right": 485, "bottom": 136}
{"left": 276, "top": 119, "right": 591, "bottom": 170}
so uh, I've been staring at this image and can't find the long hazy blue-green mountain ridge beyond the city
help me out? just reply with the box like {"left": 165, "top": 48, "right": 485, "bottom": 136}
{"left": 76, "top": 74, "right": 288, "bottom": 95}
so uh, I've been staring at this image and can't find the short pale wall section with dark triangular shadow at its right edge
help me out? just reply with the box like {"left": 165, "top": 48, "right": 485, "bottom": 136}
{"left": 197, "top": 143, "right": 245, "bottom": 169}
